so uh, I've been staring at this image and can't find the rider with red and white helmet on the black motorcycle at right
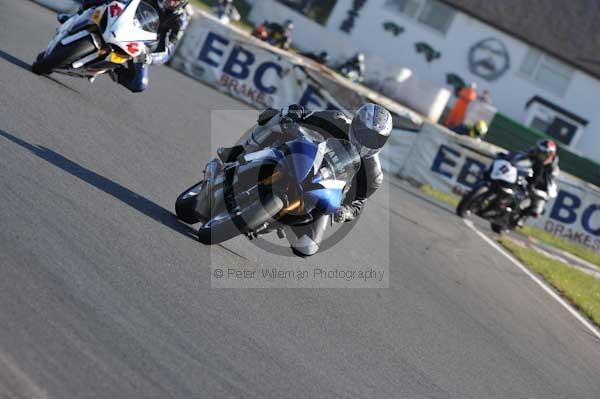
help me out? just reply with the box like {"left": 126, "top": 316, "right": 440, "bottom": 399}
{"left": 507, "top": 140, "right": 560, "bottom": 225}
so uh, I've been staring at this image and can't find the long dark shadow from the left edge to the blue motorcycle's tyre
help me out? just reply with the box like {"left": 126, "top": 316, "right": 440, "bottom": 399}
{"left": 0, "top": 129, "right": 196, "bottom": 240}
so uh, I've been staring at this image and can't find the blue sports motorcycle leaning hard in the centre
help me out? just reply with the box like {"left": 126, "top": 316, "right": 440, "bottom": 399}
{"left": 175, "top": 123, "right": 361, "bottom": 245}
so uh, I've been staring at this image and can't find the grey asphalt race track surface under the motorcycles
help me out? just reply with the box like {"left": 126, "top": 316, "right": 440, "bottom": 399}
{"left": 0, "top": 0, "right": 600, "bottom": 399}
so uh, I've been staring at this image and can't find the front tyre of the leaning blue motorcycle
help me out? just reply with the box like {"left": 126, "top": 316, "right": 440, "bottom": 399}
{"left": 198, "top": 194, "right": 284, "bottom": 245}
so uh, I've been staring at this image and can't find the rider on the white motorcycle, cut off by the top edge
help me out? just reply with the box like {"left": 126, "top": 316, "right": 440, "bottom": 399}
{"left": 75, "top": 0, "right": 189, "bottom": 93}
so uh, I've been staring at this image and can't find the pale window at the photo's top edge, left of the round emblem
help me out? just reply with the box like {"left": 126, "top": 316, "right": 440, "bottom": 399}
{"left": 385, "top": 0, "right": 456, "bottom": 34}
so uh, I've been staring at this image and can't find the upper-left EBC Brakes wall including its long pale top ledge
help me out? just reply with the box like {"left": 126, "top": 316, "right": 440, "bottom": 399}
{"left": 170, "top": 12, "right": 421, "bottom": 125}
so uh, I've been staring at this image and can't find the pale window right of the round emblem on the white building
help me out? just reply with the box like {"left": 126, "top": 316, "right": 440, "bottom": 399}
{"left": 519, "top": 48, "right": 574, "bottom": 96}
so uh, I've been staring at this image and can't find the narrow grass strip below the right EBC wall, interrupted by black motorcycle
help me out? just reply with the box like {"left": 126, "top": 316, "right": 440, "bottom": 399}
{"left": 421, "top": 185, "right": 600, "bottom": 266}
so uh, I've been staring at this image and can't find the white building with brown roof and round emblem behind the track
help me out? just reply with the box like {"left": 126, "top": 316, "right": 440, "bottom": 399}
{"left": 250, "top": 0, "right": 600, "bottom": 161}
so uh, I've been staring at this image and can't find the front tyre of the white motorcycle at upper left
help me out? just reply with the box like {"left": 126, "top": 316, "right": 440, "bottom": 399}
{"left": 31, "top": 36, "right": 96, "bottom": 75}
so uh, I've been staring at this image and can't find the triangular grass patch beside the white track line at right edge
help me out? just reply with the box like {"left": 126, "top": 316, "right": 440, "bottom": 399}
{"left": 500, "top": 238, "right": 600, "bottom": 326}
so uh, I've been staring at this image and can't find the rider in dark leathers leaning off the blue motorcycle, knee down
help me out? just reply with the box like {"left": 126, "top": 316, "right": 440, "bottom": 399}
{"left": 230, "top": 104, "right": 392, "bottom": 257}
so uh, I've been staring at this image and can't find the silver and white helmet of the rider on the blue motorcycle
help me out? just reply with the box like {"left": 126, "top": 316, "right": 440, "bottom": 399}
{"left": 348, "top": 104, "right": 392, "bottom": 158}
